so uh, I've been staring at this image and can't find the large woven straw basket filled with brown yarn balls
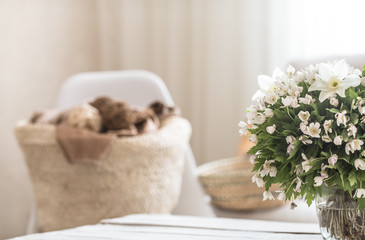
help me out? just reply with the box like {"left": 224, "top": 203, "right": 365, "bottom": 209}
{"left": 15, "top": 117, "right": 191, "bottom": 232}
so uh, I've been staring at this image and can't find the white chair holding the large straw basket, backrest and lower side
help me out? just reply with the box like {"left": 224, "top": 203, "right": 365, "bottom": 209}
{"left": 56, "top": 70, "right": 214, "bottom": 216}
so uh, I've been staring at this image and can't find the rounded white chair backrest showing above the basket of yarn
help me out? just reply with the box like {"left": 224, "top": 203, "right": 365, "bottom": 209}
{"left": 57, "top": 70, "right": 174, "bottom": 109}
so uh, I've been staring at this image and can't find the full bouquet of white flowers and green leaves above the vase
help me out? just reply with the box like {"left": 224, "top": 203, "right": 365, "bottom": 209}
{"left": 239, "top": 60, "right": 365, "bottom": 209}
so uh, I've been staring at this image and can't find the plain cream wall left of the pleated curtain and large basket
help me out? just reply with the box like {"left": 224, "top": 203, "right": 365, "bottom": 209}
{"left": 0, "top": 0, "right": 98, "bottom": 239}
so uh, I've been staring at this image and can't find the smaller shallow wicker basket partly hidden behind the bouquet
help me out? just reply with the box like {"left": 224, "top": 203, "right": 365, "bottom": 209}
{"left": 198, "top": 158, "right": 283, "bottom": 211}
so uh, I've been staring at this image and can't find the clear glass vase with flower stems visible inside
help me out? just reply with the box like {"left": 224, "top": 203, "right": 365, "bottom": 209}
{"left": 316, "top": 187, "right": 365, "bottom": 240}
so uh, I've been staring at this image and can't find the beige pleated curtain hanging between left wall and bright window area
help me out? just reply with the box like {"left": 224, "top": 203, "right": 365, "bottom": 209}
{"left": 98, "top": 0, "right": 267, "bottom": 163}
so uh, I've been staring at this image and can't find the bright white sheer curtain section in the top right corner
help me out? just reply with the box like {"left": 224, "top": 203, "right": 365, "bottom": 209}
{"left": 269, "top": 0, "right": 365, "bottom": 70}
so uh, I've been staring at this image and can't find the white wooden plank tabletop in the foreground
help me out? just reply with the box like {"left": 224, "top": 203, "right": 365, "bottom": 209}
{"left": 9, "top": 214, "right": 322, "bottom": 240}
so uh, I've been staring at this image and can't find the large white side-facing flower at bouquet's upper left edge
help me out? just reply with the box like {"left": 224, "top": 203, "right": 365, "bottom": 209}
{"left": 252, "top": 68, "right": 285, "bottom": 102}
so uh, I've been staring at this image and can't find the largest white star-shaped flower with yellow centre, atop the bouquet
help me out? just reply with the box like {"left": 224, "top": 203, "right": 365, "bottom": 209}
{"left": 308, "top": 60, "right": 361, "bottom": 102}
